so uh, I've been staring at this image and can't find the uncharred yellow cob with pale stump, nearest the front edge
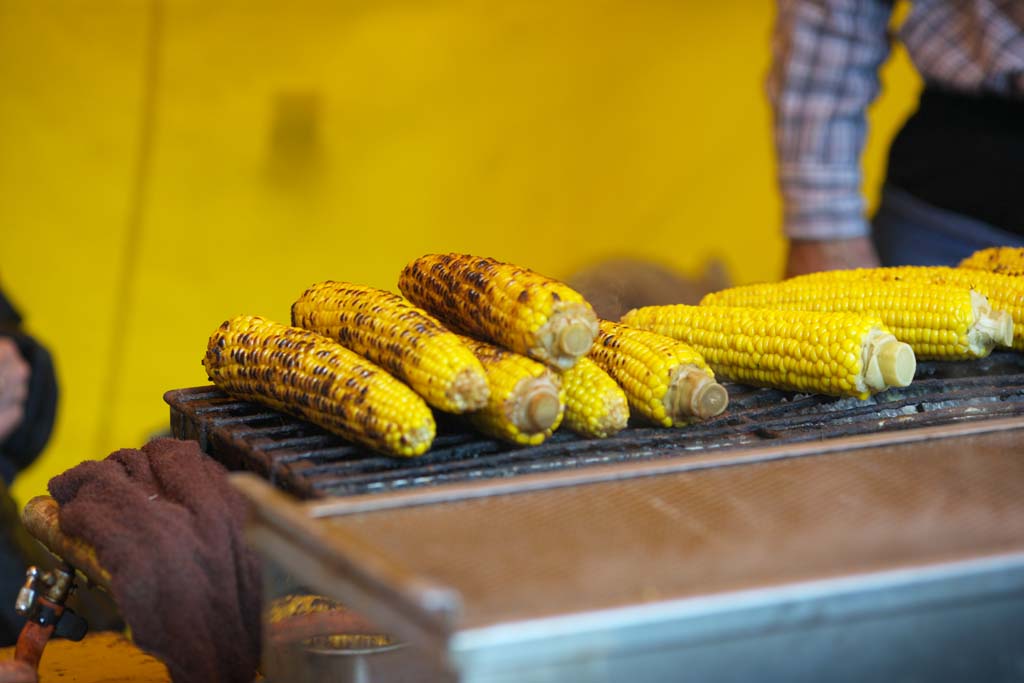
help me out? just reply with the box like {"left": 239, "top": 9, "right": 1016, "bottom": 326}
{"left": 623, "top": 304, "right": 916, "bottom": 398}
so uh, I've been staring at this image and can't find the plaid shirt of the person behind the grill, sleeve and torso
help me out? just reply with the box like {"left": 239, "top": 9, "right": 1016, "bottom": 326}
{"left": 768, "top": 0, "right": 1024, "bottom": 240}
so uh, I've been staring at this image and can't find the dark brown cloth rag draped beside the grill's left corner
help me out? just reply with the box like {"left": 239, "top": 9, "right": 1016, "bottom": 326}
{"left": 49, "top": 438, "right": 261, "bottom": 683}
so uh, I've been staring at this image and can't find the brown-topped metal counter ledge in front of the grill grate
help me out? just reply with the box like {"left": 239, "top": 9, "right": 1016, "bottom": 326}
{"left": 237, "top": 418, "right": 1024, "bottom": 681}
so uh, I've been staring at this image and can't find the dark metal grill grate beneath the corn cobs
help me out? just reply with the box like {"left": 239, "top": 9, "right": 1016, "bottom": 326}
{"left": 164, "top": 353, "right": 1024, "bottom": 499}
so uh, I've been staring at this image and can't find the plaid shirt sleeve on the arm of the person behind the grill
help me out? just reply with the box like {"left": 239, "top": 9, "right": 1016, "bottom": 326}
{"left": 768, "top": 0, "right": 892, "bottom": 240}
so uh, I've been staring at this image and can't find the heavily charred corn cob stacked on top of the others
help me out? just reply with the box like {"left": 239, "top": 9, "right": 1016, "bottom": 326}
{"left": 398, "top": 254, "right": 597, "bottom": 370}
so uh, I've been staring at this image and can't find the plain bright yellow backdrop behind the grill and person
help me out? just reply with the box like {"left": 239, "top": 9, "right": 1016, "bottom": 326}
{"left": 0, "top": 0, "right": 920, "bottom": 502}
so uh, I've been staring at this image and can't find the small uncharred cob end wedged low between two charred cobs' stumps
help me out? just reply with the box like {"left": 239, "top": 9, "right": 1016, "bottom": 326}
{"left": 562, "top": 358, "right": 630, "bottom": 438}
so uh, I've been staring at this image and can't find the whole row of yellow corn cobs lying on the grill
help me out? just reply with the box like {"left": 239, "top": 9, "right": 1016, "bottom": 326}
{"left": 204, "top": 248, "right": 1024, "bottom": 456}
